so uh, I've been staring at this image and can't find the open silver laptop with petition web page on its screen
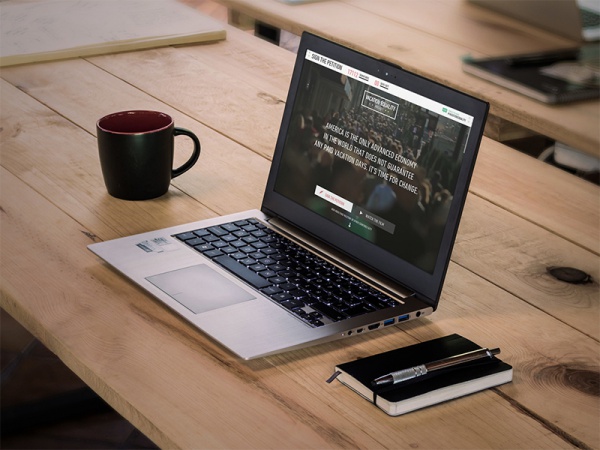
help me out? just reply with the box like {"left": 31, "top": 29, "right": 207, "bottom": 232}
{"left": 89, "top": 33, "right": 488, "bottom": 359}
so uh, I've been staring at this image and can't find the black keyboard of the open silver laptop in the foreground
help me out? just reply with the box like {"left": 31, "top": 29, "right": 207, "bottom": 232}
{"left": 175, "top": 219, "right": 398, "bottom": 327}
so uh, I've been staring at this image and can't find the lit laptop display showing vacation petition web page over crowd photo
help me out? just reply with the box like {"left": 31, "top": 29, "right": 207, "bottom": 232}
{"left": 275, "top": 50, "right": 473, "bottom": 273}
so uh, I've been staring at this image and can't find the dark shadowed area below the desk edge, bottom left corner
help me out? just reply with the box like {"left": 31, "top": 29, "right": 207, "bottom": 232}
{"left": 0, "top": 310, "right": 157, "bottom": 449}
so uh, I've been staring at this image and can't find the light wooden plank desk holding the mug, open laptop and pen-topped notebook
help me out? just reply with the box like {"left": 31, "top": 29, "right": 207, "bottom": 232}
{"left": 0, "top": 25, "right": 600, "bottom": 448}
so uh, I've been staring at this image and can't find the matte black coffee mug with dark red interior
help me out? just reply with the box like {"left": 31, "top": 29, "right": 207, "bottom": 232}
{"left": 96, "top": 110, "right": 200, "bottom": 200}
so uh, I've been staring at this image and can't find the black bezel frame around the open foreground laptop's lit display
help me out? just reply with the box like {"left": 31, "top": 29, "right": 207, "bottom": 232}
{"left": 262, "top": 32, "right": 489, "bottom": 309}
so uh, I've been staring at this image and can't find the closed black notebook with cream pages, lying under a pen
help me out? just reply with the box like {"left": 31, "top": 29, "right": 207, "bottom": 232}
{"left": 336, "top": 334, "right": 512, "bottom": 416}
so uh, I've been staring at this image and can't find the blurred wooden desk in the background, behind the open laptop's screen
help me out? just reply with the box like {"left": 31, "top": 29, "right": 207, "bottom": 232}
{"left": 218, "top": 0, "right": 600, "bottom": 157}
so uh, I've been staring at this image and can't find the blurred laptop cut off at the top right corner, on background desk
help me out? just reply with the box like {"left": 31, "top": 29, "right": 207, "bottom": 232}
{"left": 469, "top": 0, "right": 600, "bottom": 42}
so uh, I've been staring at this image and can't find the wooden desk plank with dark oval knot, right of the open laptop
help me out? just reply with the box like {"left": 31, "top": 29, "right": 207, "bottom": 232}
{"left": 452, "top": 196, "right": 600, "bottom": 340}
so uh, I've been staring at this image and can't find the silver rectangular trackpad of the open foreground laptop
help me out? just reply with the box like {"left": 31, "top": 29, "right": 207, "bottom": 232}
{"left": 146, "top": 264, "right": 256, "bottom": 314}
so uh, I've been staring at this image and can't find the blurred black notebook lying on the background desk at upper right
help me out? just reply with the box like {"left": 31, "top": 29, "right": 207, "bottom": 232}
{"left": 463, "top": 44, "right": 600, "bottom": 104}
